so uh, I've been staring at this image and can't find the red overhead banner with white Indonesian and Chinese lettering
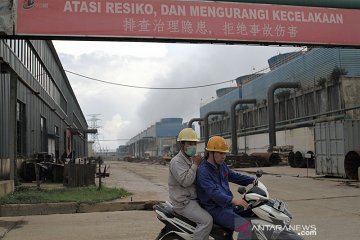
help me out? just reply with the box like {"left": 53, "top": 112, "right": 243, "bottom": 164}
{"left": 16, "top": 0, "right": 360, "bottom": 46}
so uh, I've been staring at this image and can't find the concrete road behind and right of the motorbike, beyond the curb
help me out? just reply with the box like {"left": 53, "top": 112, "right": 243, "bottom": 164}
{"left": 102, "top": 162, "right": 360, "bottom": 240}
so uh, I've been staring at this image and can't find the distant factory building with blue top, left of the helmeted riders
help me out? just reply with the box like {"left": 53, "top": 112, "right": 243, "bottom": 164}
{"left": 126, "top": 118, "right": 186, "bottom": 158}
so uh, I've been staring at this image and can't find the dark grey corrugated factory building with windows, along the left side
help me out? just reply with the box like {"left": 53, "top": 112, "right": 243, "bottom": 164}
{"left": 0, "top": 39, "right": 88, "bottom": 195}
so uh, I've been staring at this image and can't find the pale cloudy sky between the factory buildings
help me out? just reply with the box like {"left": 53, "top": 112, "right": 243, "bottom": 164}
{"left": 54, "top": 41, "right": 300, "bottom": 151}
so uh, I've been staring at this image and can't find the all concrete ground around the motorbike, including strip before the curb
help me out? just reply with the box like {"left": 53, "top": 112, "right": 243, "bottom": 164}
{"left": 0, "top": 162, "right": 360, "bottom": 240}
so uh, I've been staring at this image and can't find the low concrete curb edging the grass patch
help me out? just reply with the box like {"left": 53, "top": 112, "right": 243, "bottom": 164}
{"left": 0, "top": 201, "right": 158, "bottom": 217}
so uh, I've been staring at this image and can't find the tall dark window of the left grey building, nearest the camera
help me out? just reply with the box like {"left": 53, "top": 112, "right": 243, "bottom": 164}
{"left": 16, "top": 101, "right": 26, "bottom": 156}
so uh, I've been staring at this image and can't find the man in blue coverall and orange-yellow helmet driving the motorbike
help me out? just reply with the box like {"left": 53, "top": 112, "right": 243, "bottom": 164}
{"left": 196, "top": 136, "right": 255, "bottom": 239}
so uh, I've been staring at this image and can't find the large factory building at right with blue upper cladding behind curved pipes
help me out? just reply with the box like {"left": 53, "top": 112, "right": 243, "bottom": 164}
{"left": 198, "top": 48, "right": 360, "bottom": 177}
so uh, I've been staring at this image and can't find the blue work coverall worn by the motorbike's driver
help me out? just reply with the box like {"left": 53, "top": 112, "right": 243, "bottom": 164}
{"left": 196, "top": 159, "right": 254, "bottom": 239}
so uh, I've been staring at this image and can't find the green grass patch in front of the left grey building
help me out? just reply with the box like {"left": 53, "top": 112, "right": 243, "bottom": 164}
{"left": 0, "top": 186, "right": 131, "bottom": 204}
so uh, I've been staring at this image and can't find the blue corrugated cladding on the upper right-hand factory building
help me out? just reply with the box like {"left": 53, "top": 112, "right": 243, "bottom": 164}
{"left": 242, "top": 48, "right": 360, "bottom": 101}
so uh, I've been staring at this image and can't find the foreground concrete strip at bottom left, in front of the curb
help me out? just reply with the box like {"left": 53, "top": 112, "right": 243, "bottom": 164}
{"left": 0, "top": 211, "right": 162, "bottom": 240}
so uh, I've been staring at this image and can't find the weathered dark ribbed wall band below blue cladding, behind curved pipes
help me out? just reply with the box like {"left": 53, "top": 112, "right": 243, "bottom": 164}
{"left": 200, "top": 81, "right": 344, "bottom": 136}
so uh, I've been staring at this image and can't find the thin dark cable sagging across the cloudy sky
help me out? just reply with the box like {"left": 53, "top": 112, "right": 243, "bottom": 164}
{"left": 65, "top": 70, "right": 235, "bottom": 90}
